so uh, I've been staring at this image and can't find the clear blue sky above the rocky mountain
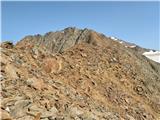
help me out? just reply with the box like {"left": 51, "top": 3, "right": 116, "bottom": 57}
{"left": 1, "top": 1, "right": 160, "bottom": 50}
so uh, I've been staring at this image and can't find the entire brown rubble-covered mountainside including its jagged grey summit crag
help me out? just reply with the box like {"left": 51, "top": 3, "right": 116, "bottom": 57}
{"left": 0, "top": 28, "right": 160, "bottom": 120}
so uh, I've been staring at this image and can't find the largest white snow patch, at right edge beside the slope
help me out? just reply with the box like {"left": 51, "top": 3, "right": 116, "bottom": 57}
{"left": 143, "top": 50, "right": 160, "bottom": 63}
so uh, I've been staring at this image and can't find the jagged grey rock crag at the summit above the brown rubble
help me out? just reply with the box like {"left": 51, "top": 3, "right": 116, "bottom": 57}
{"left": 16, "top": 27, "right": 92, "bottom": 53}
